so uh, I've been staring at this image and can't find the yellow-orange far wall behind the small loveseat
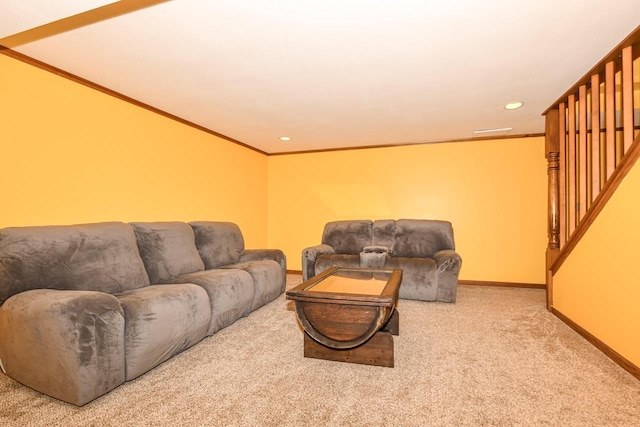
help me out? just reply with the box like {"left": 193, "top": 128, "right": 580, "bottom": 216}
{"left": 269, "top": 137, "right": 547, "bottom": 283}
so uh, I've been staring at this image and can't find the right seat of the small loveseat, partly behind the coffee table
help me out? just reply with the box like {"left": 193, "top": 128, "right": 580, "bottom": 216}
{"left": 385, "top": 257, "right": 438, "bottom": 301}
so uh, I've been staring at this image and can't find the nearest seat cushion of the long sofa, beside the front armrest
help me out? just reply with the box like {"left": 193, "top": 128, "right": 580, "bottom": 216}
{"left": 117, "top": 283, "right": 211, "bottom": 381}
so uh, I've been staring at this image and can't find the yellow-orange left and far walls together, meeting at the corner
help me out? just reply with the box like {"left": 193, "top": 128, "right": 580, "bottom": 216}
{"left": 0, "top": 51, "right": 546, "bottom": 283}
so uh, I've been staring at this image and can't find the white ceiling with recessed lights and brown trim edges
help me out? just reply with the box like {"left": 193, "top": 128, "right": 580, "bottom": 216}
{"left": 0, "top": 0, "right": 640, "bottom": 153}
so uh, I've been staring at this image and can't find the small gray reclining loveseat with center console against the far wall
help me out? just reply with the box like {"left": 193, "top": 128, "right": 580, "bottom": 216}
{"left": 302, "top": 219, "right": 462, "bottom": 302}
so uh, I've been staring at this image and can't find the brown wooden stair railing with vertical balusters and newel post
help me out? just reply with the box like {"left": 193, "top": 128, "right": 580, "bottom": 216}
{"left": 543, "top": 26, "right": 640, "bottom": 309}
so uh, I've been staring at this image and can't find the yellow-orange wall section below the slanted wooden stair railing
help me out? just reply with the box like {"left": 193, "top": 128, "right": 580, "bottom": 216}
{"left": 553, "top": 159, "right": 640, "bottom": 366}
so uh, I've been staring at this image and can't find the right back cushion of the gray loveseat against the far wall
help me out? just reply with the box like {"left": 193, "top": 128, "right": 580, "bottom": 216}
{"left": 392, "top": 219, "right": 455, "bottom": 258}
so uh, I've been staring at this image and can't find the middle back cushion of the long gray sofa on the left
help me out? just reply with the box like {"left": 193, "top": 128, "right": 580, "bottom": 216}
{"left": 131, "top": 222, "right": 204, "bottom": 283}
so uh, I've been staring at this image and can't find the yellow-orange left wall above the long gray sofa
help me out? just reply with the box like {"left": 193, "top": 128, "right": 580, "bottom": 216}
{"left": 0, "top": 55, "right": 267, "bottom": 248}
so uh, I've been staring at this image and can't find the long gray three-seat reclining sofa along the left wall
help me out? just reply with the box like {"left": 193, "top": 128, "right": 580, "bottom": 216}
{"left": 0, "top": 222, "right": 286, "bottom": 405}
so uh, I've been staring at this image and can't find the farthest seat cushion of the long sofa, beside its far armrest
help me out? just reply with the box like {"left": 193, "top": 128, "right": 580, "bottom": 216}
{"left": 223, "top": 260, "right": 284, "bottom": 311}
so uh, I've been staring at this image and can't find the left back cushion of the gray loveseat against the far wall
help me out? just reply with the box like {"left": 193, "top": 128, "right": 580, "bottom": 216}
{"left": 322, "top": 220, "right": 373, "bottom": 255}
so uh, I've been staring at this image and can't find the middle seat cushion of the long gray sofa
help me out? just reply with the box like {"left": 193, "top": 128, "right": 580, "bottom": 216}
{"left": 173, "top": 269, "right": 255, "bottom": 335}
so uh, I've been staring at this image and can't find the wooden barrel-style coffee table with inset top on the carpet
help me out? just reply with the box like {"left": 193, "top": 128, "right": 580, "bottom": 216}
{"left": 286, "top": 267, "right": 402, "bottom": 367}
